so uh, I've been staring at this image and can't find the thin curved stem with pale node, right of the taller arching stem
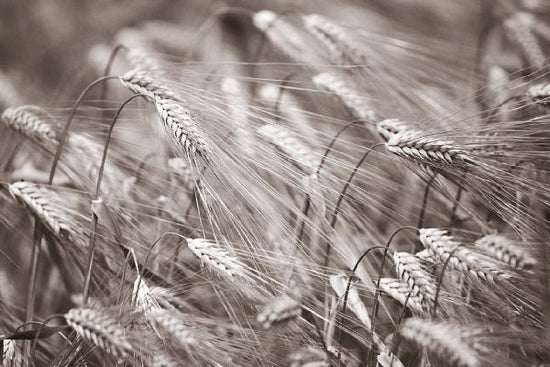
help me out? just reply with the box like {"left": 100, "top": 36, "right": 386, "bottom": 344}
{"left": 82, "top": 94, "right": 149, "bottom": 306}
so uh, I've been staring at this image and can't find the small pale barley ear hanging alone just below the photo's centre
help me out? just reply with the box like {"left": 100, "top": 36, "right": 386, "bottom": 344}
{"left": 187, "top": 238, "right": 244, "bottom": 277}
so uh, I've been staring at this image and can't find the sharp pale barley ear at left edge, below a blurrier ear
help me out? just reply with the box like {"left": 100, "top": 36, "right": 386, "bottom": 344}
{"left": 8, "top": 181, "right": 71, "bottom": 237}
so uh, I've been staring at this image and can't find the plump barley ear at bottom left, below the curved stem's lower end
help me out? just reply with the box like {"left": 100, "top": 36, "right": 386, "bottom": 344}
{"left": 65, "top": 308, "right": 133, "bottom": 358}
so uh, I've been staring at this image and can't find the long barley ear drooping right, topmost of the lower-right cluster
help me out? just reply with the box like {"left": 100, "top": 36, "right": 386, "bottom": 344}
{"left": 419, "top": 228, "right": 509, "bottom": 281}
